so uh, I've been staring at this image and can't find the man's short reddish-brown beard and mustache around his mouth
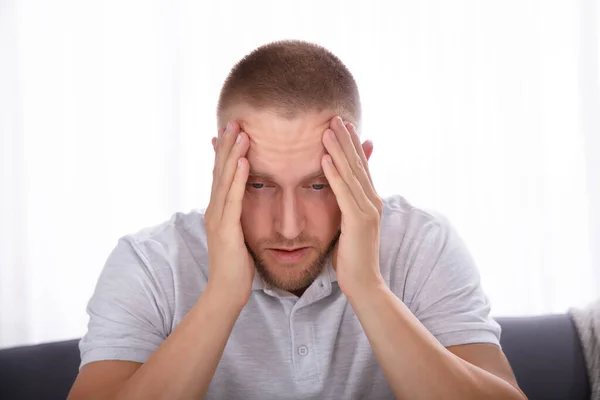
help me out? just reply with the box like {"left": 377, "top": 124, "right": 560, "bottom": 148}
{"left": 244, "top": 230, "right": 341, "bottom": 292}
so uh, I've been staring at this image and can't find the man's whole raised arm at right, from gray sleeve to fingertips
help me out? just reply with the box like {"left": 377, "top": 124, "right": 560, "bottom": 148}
{"left": 321, "top": 117, "right": 525, "bottom": 400}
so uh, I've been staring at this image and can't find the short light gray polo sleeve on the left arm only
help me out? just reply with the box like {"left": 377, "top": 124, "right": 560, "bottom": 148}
{"left": 79, "top": 238, "right": 169, "bottom": 369}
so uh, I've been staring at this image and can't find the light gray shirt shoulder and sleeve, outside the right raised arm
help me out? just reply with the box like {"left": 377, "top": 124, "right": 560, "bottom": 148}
{"left": 381, "top": 196, "right": 500, "bottom": 346}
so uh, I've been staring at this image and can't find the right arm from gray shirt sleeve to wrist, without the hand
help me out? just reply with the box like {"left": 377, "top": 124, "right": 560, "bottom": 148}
{"left": 351, "top": 218, "right": 524, "bottom": 399}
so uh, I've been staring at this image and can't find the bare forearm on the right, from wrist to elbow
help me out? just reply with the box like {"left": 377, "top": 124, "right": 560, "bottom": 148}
{"left": 349, "top": 284, "right": 524, "bottom": 400}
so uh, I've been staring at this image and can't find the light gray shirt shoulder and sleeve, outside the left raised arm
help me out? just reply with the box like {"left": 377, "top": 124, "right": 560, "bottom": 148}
{"left": 79, "top": 212, "right": 210, "bottom": 366}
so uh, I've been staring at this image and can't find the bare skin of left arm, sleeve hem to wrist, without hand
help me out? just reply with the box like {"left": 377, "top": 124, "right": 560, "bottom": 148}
{"left": 68, "top": 287, "right": 242, "bottom": 400}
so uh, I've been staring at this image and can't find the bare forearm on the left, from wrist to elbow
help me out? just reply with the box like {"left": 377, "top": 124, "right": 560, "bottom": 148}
{"left": 114, "top": 285, "right": 242, "bottom": 400}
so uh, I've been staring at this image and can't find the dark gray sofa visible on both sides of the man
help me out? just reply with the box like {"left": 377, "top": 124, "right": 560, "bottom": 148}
{"left": 0, "top": 315, "right": 590, "bottom": 400}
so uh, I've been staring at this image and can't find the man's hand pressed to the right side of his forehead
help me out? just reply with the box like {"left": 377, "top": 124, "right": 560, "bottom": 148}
{"left": 321, "top": 117, "right": 385, "bottom": 297}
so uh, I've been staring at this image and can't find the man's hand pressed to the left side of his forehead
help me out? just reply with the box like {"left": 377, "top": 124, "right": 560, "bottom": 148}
{"left": 204, "top": 121, "right": 254, "bottom": 305}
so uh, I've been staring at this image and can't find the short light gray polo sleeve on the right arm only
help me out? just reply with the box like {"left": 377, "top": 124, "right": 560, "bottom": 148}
{"left": 407, "top": 217, "right": 501, "bottom": 347}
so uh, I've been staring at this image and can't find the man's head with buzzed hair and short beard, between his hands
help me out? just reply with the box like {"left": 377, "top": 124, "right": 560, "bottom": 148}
{"left": 217, "top": 41, "right": 360, "bottom": 291}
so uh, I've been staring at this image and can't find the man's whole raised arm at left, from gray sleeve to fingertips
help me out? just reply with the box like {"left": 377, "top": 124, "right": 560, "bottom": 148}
{"left": 69, "top": 123, "right": 254, "bottom": 400}
